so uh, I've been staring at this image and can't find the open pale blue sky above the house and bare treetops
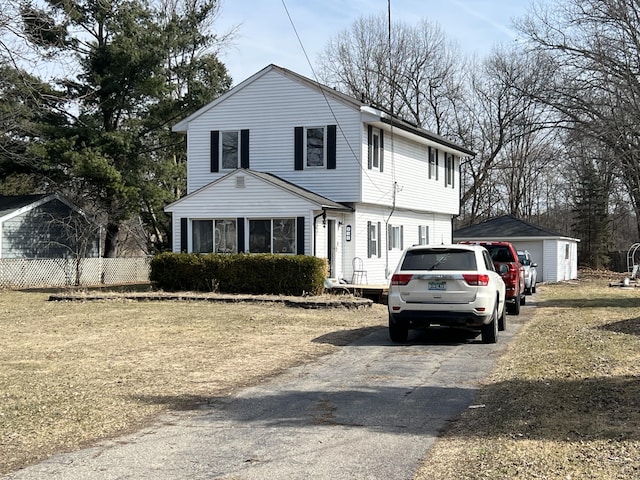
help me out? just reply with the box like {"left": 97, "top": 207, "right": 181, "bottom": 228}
{"left": 216, "top": 0, "right": 530, "bottom": 84}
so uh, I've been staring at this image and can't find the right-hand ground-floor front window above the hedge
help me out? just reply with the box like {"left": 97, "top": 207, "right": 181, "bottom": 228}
{"left": 249, "top": 218, "right": 297, "bottom": 254}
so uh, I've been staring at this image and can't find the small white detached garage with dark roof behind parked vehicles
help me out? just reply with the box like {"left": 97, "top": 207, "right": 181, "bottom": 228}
{"left": 453, "top": 215, "right": 580, "bottom": 282}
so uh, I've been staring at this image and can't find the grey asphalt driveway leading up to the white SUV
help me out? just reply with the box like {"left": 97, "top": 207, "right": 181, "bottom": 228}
{"left": 1, "top": 307, "right": 530, "bottom": 480}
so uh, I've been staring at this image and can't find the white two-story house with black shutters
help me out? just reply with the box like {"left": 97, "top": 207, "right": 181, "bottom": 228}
{"left": 166, "top": 65, "right": 473, "bottom": 284}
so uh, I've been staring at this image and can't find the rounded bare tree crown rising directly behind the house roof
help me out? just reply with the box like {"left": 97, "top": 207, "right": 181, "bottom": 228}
{"left": 318, "top": 15, "right": 462, "bottom": 135}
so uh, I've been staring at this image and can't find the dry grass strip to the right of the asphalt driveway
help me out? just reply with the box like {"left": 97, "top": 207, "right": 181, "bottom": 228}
{"left": 416, "top": 279, "right": 640, "bottom": 480}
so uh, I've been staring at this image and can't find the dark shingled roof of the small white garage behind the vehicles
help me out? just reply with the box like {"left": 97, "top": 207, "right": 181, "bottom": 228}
{"left": 453, "top": 215, "right": 566, "bottom": 239}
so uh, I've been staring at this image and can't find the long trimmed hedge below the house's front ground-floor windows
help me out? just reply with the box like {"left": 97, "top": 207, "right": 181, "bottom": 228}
{"left": 149, "top": 253, "right": 327, "bottom": 295}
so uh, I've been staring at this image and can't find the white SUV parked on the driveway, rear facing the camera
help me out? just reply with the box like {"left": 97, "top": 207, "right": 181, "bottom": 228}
{"left": 388, "top": 244, "right": 506, "bottom": 343}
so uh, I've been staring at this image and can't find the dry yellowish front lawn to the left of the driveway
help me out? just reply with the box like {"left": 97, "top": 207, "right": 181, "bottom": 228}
{"left": 0, "top": 291, "right": 387, "bottom": 474}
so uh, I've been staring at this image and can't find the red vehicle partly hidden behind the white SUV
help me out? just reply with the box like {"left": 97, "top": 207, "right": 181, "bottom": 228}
{"left": 461, "top": 241, "right": 526, "bottom": 315}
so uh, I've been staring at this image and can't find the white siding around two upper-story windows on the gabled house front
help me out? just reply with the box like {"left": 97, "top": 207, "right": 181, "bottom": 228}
{"left": 182, "top": 71, "right": 362, "bottom": 202}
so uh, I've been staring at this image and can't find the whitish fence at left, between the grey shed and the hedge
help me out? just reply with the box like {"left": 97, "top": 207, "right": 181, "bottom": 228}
{"left": 0, "top": 257, "right": 151, "bottom": 289}
